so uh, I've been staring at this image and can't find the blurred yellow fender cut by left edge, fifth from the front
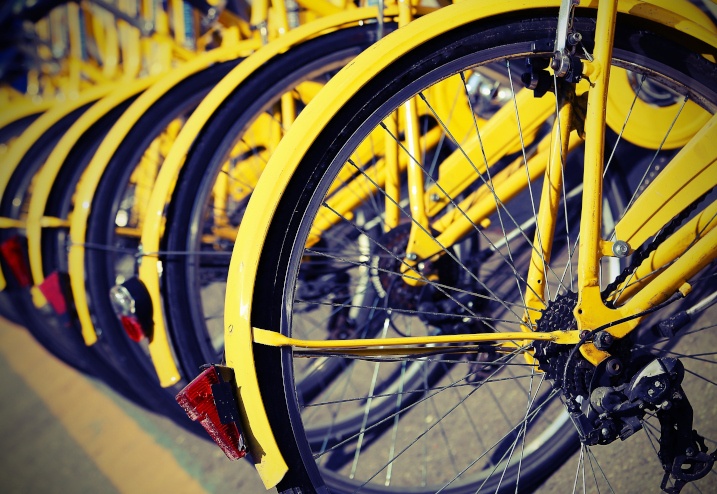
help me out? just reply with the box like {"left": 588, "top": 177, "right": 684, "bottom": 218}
{"left": 0, "top": 84, "right": 121, "bottom": 290}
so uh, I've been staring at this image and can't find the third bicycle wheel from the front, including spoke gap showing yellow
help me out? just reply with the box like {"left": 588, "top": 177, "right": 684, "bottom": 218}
{"left": 79, "top": 61, "right": 238, "bottom": 424}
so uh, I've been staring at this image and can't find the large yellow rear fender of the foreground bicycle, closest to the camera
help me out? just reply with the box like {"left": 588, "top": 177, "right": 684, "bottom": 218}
{"left": 224, "top": 0, "right": 717, "bottom": 488}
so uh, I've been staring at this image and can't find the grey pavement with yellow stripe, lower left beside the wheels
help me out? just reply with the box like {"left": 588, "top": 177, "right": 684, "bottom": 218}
{"left": 0, "top": 319, "right": 275, "bottom": 494}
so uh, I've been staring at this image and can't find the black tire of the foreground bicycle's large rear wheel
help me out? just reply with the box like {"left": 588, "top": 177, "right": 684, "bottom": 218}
{"left": 243, "top": 7, "right": 717, "bottom": 492}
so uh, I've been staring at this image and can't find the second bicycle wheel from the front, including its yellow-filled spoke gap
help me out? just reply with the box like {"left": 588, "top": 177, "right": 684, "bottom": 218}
{"left": 162, "top": 23, "right": 393, "bottom": 377}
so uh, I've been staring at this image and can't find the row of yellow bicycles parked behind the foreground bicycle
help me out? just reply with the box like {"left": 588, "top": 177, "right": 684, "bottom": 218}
{"left": 0, "top": 0, "right": 334, "bottom": 433}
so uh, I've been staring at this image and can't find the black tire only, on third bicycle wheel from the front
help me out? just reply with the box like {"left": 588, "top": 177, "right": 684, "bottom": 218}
{"left": 73, "top": 61, "right": 238, "bottom": 426}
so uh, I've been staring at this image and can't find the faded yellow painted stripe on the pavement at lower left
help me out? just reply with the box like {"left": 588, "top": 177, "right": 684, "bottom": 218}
{"left": 0, "top": 319, "right": 206, "bottom": 493}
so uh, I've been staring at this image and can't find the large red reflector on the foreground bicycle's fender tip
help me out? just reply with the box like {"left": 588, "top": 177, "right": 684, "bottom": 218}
{"left": 176, "top": 366, "right": 246, "bottom": 460}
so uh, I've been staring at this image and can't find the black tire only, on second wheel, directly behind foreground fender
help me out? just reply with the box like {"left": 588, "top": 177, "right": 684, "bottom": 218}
{"left": 162, "top": 25, "right": 393, "bottom": 382}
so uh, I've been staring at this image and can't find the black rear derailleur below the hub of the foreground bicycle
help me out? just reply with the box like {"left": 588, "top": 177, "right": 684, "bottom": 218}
{"left": 535, "top": 297, "right": 717, "bottom": 494}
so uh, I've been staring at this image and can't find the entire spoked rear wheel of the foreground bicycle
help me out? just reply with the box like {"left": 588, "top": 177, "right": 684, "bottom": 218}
{"left": 242, "top": 6, "right": 717, "bottom": 493}
